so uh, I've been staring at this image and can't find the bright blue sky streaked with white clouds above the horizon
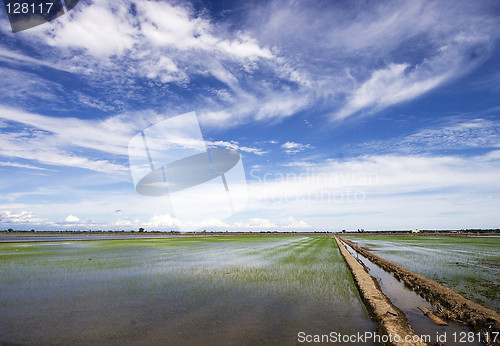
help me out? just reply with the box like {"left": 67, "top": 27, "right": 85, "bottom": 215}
{"left": 0, "top": 0, "right": 500, "bottom": 231}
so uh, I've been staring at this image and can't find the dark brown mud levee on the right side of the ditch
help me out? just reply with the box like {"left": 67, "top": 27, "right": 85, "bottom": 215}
{"left": 341, "top": 238, "right": 500, "bottom": 344}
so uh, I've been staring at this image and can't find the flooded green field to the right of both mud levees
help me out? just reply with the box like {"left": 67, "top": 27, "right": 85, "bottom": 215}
{"left": 345, "top": 235, "right": 500, "bottom": 312}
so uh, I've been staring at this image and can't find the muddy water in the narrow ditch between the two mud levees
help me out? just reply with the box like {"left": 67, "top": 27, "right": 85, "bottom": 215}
{"left": 344, "top": 243, "right": 483, "bottom": 345}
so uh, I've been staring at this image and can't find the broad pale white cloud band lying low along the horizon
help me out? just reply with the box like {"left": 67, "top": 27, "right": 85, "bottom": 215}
{"left": 0, "top": 146, "right": 500, "bottom": 230}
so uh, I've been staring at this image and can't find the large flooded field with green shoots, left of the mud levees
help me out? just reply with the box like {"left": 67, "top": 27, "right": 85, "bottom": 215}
{"left": 0, "top": 236, "right": 376, "bottom": 345}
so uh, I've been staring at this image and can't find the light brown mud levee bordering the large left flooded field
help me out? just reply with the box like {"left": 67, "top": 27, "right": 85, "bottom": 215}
{"left": 335, "top": 237, "right": 427, "bottom": 346}
